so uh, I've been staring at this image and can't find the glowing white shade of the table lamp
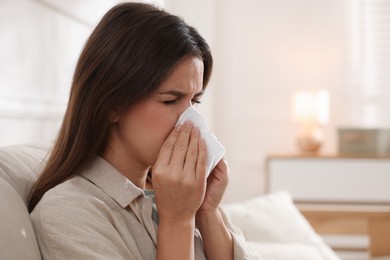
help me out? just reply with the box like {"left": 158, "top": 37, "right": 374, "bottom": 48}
{"left": 292, "top": 89, "right": 329, "bottom": 124}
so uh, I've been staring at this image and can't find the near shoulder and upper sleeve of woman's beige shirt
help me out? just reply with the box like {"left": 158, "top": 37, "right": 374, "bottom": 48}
{"left": 30, "top": 176, "right": 139, "bottom": 259}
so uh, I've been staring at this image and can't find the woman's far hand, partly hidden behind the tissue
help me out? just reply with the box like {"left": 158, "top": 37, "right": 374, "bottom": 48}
{"left": 197, "top": 158, "right": 230, "bottom": 217}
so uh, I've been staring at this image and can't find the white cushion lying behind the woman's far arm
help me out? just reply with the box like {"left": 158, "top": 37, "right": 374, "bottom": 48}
{"left": 222, "top": 192, "right": 339, "bottom": 260}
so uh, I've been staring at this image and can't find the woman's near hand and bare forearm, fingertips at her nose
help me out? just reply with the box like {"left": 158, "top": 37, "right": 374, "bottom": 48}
{"left": 153, "top": 122, "right": 207, "bottom": 260}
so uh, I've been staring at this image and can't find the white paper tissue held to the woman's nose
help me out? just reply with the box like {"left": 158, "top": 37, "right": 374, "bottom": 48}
{"left": 176, "top": 106, "right": 226, "bottom": 176}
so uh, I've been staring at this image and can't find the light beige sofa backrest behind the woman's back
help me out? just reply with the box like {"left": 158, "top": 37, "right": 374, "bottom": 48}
{"left": 0, "top": 145, "right": 48, "bottom": 260}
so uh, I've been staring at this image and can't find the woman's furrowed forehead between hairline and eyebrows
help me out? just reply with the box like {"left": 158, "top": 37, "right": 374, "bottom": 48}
{"left": 159, "top": 57, "right": 203, "bottom": 92}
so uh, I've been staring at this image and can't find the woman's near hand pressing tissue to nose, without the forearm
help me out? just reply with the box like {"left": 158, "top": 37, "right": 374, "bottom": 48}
{"left": 153, "top": 122, "right": 207, "bottom": 223}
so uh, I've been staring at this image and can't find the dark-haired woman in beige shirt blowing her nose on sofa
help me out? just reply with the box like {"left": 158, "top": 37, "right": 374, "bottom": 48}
{"left": 29, "top": 3, "right": 256, "bottom": 260}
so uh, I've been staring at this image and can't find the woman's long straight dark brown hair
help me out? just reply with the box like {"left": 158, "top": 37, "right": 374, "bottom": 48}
{"left": 29, "top": 3, "right": 213, "bottom": 212}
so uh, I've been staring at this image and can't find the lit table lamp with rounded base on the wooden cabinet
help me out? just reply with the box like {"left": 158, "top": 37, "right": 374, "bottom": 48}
{"left": 293, "top": 89, "right": 329, "bottom": 153}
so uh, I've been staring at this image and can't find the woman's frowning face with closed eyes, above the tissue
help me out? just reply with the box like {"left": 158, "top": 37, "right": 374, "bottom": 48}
{"left": 109, "top": 57, "right": 203, "bottom": 169}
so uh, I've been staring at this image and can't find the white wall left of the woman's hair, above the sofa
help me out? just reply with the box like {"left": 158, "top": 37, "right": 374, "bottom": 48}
{"left": 0, "top": 0, "right": 90, "bottom": 145}
